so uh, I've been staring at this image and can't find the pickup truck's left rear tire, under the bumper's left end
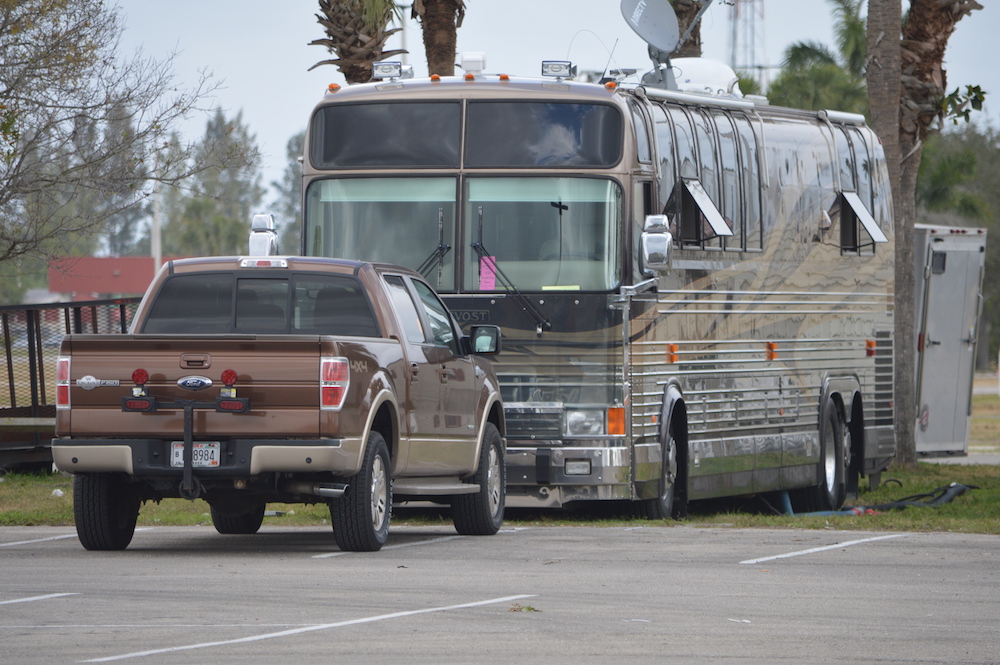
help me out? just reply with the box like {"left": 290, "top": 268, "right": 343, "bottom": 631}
{"left": 73, "top": 473, "right": 142, "bottom": 550}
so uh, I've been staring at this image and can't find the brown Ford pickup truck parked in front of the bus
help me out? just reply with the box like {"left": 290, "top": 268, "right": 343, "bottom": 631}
{"left": 52, "top": 257, "right": 506, "bottom": 551}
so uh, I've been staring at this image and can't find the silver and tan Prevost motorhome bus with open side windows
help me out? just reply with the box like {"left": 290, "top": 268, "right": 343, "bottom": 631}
{"left": 262, "top": 44, "right": 895, "bottom": 518}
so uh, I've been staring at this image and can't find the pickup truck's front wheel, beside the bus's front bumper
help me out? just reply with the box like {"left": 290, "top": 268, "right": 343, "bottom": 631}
{"left": 451, "top": 423, "right": 507, "bottom": 536}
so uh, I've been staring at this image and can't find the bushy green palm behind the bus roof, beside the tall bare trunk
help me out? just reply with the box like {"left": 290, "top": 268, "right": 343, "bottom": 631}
{"left": 768, "top": 0, "right": 868, "bottom": 113}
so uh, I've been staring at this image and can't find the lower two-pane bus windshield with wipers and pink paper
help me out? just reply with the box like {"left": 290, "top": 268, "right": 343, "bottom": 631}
{"left": 305, "top": 177, "right": 622, "bottom": 292}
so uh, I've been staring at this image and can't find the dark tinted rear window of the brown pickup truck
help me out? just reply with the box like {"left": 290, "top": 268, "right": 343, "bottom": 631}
{"left": 140, "top": 271, "right": 380, "bottom": 337}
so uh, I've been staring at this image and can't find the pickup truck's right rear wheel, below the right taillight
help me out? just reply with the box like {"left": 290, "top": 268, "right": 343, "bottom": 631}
{"left": 330, "top": 432, "right": 392, "bottom": 552}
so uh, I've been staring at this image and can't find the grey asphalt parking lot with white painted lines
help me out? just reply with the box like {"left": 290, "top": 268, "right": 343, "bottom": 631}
{"left": 0, "top": 526, "right": 1000, "bottom": 665}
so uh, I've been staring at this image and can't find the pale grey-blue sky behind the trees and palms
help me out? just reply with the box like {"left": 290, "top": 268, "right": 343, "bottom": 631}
{"left": 117, "top": 0, "right": 1000, "bottom": 203}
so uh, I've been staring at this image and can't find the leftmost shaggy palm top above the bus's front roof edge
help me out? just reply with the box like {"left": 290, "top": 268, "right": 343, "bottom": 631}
{"left": 309, "top": 0, "right": 406, "bottom": 83}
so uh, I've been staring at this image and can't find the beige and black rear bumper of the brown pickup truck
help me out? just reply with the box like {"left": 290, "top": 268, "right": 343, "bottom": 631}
{"left": 52, "top": 439, "right": 361, "bottom": 478}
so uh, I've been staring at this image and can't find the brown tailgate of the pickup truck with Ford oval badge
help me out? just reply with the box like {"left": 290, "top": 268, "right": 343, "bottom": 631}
{"left": 56, "top": 335, "right": 326, "bottom": 438}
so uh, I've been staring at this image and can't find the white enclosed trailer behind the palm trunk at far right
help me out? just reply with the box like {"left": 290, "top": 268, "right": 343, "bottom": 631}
{"left": 914, "top": 224, "right": 986, "bottom": 456}
